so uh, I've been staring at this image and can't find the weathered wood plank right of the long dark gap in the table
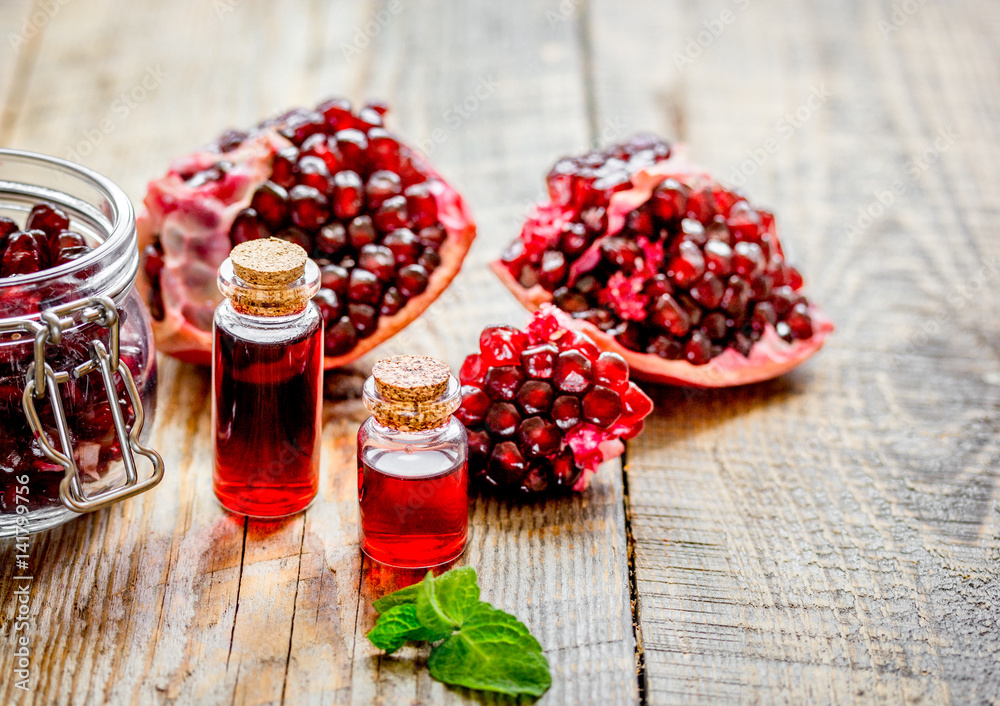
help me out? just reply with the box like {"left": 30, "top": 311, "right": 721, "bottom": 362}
{"left": 590, "top": 0, "right": 1000, "bottom": 703}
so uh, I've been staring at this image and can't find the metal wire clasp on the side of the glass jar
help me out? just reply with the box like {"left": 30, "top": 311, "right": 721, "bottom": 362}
{"left": 21, "top": 296, "right": 163, "bottom": 512}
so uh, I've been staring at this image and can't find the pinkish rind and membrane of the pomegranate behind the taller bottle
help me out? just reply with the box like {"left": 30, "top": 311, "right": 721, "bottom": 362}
{"left": 136, "top": 127, "right": 476, "bottom": 370}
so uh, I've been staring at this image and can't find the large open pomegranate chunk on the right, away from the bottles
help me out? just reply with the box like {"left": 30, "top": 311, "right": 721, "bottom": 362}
{"left": 491, "top": 135, "right": 833, "bottom": 387}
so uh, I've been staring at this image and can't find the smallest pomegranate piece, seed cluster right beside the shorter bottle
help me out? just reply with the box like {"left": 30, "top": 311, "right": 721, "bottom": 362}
{"left": 455, "top": 305, "right": 653, "bottom": 495}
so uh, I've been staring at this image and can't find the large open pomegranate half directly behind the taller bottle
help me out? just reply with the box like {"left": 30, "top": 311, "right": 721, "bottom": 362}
{"left": 137, "top": 99, "right": 476, "bottom": 369}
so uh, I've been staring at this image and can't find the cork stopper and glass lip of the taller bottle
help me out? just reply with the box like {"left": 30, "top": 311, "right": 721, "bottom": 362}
{"left": 219, "top": 238, "right": 319, "bottom": 316}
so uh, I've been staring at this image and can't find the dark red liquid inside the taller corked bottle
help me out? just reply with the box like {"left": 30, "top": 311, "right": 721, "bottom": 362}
{"left": 212, "top": 325, "right": 323, "bottom": 517}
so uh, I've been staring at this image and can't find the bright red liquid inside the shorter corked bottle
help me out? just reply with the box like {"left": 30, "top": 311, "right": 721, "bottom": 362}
{"left": 358, "top": 449, "right": 469, "bottom": 568}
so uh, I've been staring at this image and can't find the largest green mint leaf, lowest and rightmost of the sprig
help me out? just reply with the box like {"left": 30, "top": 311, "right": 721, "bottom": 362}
{"left": 426, "top": 603, "right": 552, "bottom": 698}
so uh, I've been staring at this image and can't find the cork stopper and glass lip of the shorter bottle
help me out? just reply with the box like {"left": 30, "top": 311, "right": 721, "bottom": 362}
{"left": 364, "top": 355, "right": 461, "bottom": 432}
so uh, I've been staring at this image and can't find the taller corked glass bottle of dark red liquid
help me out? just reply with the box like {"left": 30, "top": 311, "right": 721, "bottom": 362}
{"left": 212, "top": 238, "right": 323, "bottom": 517}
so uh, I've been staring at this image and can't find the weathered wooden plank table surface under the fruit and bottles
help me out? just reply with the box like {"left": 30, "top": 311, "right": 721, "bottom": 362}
{"left": 0, "top": 0, "right": 1000, "bottom": 704}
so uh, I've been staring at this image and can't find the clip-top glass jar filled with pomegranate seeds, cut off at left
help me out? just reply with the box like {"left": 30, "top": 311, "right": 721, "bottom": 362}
{"left": 0, "top": 150, "right": 163, "bottom": 537}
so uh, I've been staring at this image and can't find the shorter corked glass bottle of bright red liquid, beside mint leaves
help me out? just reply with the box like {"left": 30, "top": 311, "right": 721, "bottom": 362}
{"left": 358, "top": 355, "right": 469, "bottom": 568}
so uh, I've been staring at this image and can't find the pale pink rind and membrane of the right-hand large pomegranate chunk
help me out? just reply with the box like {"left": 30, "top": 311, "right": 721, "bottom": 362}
{"left": 490, "top": 146, "right": 834, "bottom": 388}
